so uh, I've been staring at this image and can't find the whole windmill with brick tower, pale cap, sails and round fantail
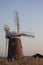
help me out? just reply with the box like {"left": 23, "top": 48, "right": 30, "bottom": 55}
{"left": 4, "top": 11, "right": 34, "bottom": 60}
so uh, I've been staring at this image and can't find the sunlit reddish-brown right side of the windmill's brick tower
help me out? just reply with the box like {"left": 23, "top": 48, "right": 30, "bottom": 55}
{"left": 16, "top": 38, "right": 22, "bottom": 59}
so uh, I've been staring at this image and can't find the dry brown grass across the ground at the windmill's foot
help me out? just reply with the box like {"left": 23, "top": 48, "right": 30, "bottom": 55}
{"left": 0, "top": 58, "right": 43, "bottom": 65}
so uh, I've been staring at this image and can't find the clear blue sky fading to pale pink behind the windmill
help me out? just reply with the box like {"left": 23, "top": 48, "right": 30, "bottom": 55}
{"left": 0, "top": 0, "right": 43, "bottom": 56}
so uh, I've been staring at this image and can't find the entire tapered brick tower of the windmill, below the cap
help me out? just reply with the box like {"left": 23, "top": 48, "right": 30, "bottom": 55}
{"left": 8, "top": 38, "right": 22, "bottom": 59}
